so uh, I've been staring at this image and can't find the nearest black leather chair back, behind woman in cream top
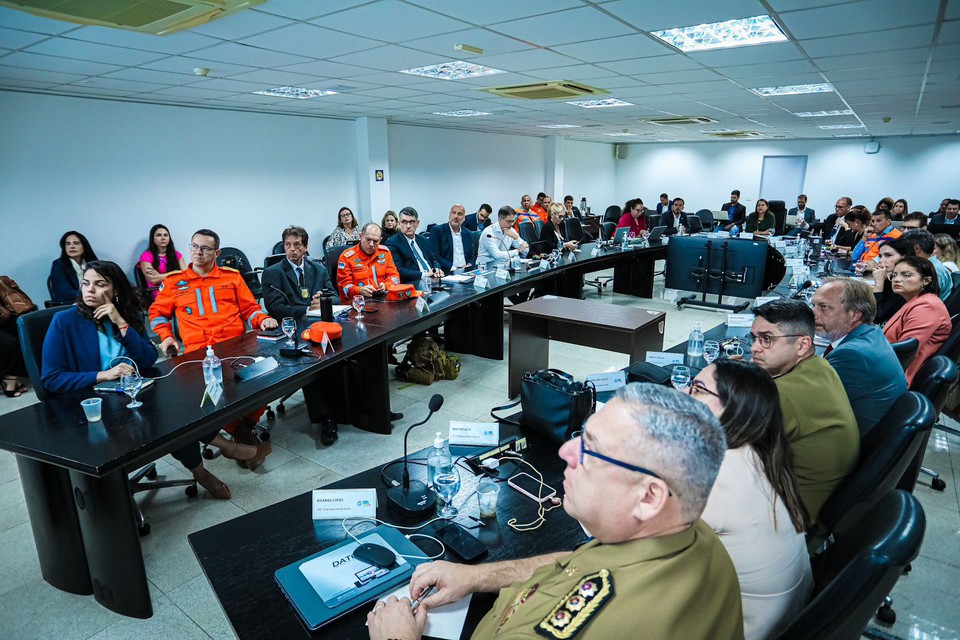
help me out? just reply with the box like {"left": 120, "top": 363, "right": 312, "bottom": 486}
{"left": 777, "top": 491, "right": 926, "bottom": 640}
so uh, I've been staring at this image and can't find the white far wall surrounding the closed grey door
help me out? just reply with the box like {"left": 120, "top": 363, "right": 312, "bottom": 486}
{"left": 616, "top": 136, "right": 960, "bottom": 217}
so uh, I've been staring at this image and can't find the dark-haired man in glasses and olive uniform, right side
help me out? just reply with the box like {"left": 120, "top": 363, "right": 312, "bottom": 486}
{"left": 749, "top": 300, "right": 860, "bottom": 522}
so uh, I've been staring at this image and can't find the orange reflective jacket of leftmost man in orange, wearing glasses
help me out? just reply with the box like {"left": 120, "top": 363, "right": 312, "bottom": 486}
{"left": 150, "top": 264, "right": 270, "bottom": 351}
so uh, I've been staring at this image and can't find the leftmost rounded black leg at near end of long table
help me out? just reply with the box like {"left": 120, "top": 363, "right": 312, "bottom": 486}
{"left": 17, "top": 456, "right": 93, "bottom": 596}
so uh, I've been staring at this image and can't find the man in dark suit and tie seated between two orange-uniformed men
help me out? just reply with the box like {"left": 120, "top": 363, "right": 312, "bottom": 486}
{"left": 260, "top": 227, "right": 340, "bottom": 446}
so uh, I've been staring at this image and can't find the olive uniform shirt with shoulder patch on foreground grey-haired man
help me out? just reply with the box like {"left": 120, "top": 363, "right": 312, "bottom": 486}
{"left": 472, "top": 520, "right": 743, "bottom": 640}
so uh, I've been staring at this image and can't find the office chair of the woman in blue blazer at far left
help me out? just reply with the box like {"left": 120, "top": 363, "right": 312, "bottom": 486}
{"left": 17, "top": 308, "right": 197, "bottom": 537}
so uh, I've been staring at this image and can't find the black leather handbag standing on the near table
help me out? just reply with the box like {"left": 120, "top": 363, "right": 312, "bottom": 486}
{"left": 490, "top": 369, "right": 597, "bottom": 442}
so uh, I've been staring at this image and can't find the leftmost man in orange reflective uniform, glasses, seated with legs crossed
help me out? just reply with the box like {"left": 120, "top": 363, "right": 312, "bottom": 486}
{"left": 150, "top": 229, "right": 277, "bottom": 469}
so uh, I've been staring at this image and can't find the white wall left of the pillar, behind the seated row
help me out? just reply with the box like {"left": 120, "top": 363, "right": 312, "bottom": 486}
{"left": 0, "top": 92, "right": 361, "bottom": 303}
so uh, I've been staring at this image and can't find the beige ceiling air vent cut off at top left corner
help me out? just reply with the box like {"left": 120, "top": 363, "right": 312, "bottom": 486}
{"left": 0, "top": 0, "right": 265, "bottom": 36}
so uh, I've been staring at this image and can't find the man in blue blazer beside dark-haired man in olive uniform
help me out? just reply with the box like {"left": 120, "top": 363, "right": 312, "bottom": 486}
{"left": 811, "top": 278, "right": 907, "bottom": 438}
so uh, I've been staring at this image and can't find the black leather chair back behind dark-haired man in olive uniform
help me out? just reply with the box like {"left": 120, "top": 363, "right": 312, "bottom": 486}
{"left": 817, "top": 391, "right": 937, "bottom": 537}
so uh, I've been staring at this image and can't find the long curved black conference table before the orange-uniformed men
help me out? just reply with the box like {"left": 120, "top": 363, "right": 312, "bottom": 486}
{"left": 0, "top": 239, "right": 666, "bottom": 618}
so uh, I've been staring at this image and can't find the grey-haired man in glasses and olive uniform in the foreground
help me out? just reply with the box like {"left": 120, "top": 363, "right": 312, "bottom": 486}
{"left": 367, "top": 384, "right": 743, "bottom": 640}
